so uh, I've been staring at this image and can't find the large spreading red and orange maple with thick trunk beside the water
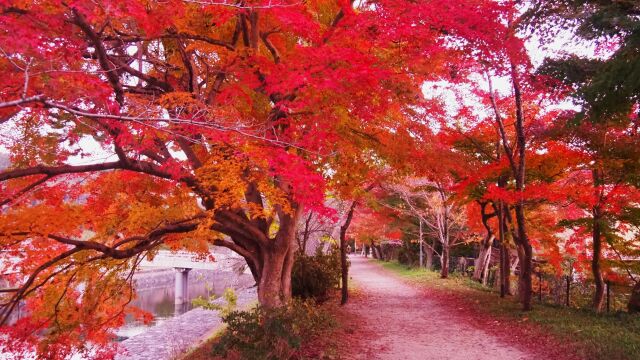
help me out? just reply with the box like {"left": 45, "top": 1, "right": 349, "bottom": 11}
{"left": 0, "top": 0, "right": 444, "bottom": 357}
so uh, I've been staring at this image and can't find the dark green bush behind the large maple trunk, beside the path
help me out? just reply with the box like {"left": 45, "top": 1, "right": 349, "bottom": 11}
{"left": 291, "top": 249, "right": 341, "bottom": 302}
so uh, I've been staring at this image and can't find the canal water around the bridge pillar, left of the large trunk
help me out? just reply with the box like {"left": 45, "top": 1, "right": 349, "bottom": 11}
{"left": 117, "top": 270, "right": 252, "bottom": 337}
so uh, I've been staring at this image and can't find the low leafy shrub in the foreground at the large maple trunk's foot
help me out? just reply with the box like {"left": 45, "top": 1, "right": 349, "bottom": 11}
{"left": 213, "top": 300, "right": 335, "bottom": 360}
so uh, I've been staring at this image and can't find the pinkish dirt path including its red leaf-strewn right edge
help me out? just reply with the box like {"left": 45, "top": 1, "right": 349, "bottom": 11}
{"left": 341, "top": 256, "right": 576, "bottom": 360}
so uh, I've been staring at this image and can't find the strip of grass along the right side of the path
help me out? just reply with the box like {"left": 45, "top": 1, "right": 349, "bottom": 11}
{"left": 380, "top": 262, "right": 640, "bottom": 359}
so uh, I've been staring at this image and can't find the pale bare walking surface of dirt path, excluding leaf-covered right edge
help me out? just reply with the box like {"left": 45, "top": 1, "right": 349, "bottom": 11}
{"left": 349, "top": 256, "right": 534, "bottom": 360}
